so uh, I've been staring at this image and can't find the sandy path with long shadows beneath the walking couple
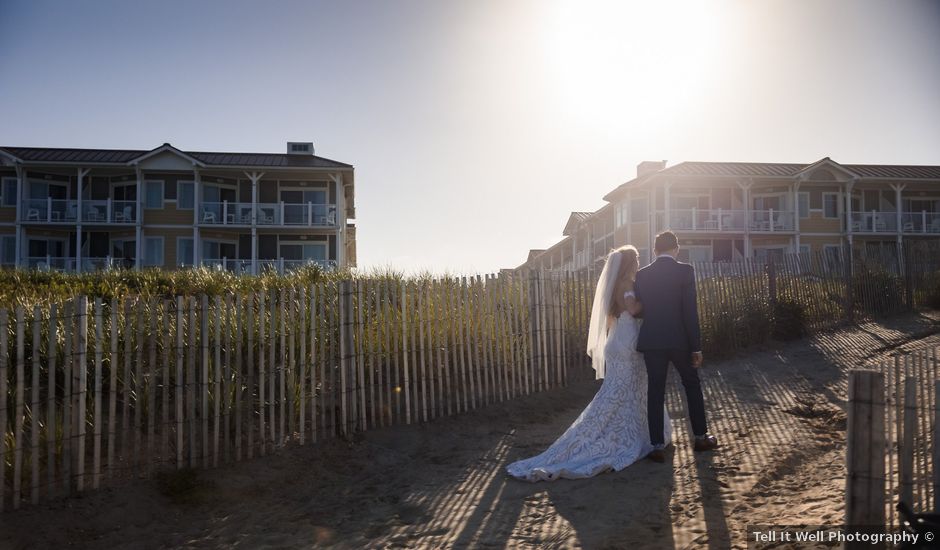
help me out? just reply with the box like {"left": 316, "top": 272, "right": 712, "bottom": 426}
{"left": 0, "top": 316, "right": 940, "bottom": 548}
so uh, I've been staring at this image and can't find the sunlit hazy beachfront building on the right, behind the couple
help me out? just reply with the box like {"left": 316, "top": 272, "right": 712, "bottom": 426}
{"left": 521, "top": 158, "right": 940, "bottom": 269}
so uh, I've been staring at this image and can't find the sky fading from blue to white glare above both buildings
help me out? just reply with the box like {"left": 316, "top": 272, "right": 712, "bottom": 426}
{"left": 0, "top": 0, "right": 940, "bottom": 274}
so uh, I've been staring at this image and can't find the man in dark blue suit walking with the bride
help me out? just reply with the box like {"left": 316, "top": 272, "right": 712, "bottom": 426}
{"left": 633, "top": 231, "right": 718, "bottom": 462}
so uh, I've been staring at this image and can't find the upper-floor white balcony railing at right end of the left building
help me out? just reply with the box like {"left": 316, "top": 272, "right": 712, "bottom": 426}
{"left": 199, "top": 202, "right": 336, "bottom": 227}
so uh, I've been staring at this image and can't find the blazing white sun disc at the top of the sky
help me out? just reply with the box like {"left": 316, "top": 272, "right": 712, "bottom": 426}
{"left": 544, "top": 0, "right": 721, "bottom": 135}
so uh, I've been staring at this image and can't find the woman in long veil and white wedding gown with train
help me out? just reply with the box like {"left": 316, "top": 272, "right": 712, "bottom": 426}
{"left": 506, "top": 245, "right": 672, "bottom": 481}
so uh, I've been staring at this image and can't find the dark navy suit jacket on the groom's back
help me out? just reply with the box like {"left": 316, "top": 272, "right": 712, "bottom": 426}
{"left": 633, "top": 257, "right": 702, "bottom": 352}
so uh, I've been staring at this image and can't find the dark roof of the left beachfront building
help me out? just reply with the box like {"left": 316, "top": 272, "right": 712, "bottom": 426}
{"left": 0, "top": 143, "right": 352, "bottom": 168}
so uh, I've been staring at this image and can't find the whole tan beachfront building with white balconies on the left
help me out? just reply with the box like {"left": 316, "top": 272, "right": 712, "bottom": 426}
{"left": 0, "top": 142, "right": 356, "bottom": 273}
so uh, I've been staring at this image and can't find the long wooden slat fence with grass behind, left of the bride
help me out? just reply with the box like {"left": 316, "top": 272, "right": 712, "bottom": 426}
{"left": 0, "top": 273, "right": 593, "bottom": 509}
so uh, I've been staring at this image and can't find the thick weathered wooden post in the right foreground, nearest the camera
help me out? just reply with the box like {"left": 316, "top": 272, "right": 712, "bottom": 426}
{"left": 845, "top": 370, "right": 885, "bottom": 536}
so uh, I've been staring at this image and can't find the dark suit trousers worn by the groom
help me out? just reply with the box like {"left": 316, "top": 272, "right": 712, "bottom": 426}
{"left": 643, "top": 350, "right": 708, "bottom": 445}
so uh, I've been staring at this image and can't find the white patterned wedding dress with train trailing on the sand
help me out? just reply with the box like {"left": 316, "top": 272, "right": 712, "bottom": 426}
{"left": 506, "top": 313, "right": 672, "bottom": 481}
